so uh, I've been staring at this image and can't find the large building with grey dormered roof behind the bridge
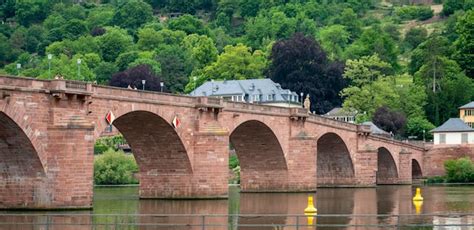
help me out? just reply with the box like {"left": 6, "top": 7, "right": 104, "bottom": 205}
{"left": 189, "top": 78, "right": 301, "bottom": 107}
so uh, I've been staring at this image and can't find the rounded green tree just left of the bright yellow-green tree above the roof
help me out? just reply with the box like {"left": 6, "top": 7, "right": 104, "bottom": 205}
{"left": 183, "top": 34, "right": 217, "bottom": 68}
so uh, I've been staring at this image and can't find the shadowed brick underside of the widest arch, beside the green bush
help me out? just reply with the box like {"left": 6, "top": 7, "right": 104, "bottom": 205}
{"left": 113, "top": 111, "right": 193, "bottom": 197}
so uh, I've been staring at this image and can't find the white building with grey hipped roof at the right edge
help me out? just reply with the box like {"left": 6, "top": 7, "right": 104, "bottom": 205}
{"left": 431, "top": 118, "right": 474, "bottom": 145}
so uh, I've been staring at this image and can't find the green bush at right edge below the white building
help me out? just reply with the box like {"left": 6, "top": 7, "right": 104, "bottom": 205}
{"left": 444, "top": 157, "right": 474, "bottom": 183}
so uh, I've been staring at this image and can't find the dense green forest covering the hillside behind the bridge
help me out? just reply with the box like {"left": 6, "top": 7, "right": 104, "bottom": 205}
{"left": 0, "top": 0, "right": 474, "bottom": 139}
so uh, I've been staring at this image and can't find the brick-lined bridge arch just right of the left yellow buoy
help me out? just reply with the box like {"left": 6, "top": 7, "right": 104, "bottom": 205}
{"left": 316, "top": 132, "right": 355, "bottom": 186}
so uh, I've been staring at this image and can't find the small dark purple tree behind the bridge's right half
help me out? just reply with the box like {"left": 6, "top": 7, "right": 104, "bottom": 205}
{"left": 372, "top": 106, "right": 407, "bottom": 135}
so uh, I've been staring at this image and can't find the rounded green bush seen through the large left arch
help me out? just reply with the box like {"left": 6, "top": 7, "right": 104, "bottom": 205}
{"left": 94, "top": 149, "right": 138, "bottom": 185}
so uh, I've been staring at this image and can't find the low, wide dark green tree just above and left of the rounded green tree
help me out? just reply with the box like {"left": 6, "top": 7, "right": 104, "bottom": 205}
{"left": 168, "top": 14, "right": 209, "bottom": 35}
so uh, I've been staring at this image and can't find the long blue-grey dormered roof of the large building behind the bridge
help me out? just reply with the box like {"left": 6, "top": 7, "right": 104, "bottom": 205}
{"left": 190, "top": 78, "right": 299, "bottom": 102}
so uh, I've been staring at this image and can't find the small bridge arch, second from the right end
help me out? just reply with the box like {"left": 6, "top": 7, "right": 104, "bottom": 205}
{"left": 376, "top": 147, "right": 398, "bottom": 184}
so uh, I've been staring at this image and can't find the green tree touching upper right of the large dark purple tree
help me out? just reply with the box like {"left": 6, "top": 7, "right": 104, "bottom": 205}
{"left": 319, "top": 25, "right": 350, "bottom": 60}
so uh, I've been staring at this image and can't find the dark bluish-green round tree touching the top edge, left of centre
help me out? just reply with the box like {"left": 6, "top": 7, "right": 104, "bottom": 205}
{"left": 112, "top": 0, "right": 153, "bottom": 31}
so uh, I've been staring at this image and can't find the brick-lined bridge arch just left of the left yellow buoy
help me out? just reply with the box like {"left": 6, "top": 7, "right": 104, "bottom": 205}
{"left": 230, "top": 120, "right": 288, "bottom": 191}
